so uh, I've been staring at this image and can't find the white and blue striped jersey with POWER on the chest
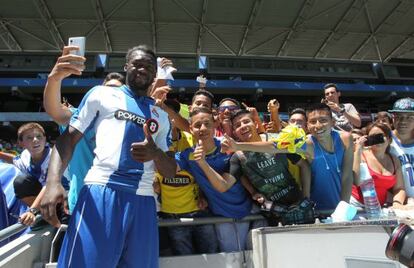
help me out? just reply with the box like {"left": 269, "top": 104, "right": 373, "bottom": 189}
{"left": 70, "top": 85, "right": 171, "bottom": 196}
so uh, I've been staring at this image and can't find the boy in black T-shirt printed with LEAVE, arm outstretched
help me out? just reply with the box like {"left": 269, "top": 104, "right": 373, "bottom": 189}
{"left": 230, "top": 110, "right": 314, "bottom": 223}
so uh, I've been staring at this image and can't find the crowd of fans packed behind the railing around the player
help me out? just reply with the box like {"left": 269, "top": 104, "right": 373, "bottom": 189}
{"left": 1, "top": 44, "right": 414, "bottom": 266}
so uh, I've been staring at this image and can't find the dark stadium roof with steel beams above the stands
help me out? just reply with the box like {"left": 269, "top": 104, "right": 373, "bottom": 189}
{"left": 0, "top": 0, "right": 414, "bottom": 62}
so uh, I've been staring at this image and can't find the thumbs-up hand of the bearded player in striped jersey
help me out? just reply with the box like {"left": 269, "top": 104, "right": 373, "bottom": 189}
{"left": 130, "top": 123, "right": 162, "bottom": 163}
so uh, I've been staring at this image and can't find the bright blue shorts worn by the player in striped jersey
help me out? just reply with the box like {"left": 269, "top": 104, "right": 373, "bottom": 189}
{"left": 58, "top": 185, "right": 158, "bottom": 268}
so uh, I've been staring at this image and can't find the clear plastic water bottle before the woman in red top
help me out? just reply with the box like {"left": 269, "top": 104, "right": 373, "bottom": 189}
{"left": 359, "top": 163, "right": 381, "bottom": 219}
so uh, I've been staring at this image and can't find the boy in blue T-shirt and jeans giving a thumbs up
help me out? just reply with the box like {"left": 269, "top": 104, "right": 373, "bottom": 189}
{"left": 176, "top": 107, "right": 252, "bottom": 252}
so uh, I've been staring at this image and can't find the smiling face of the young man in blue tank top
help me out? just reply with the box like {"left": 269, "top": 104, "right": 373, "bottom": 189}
{"left": 308, "top": 110, "right": 334, "bottom": 139}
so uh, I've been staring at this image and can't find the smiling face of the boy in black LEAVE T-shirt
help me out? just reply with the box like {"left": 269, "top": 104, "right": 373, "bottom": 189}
{"left": 233, "top": 114, "right": 258, "bottom": 142}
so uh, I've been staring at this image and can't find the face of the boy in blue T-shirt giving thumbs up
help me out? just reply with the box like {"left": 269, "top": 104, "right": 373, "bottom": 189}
{"left": 190, "top": 112, "right": 214, "bottom": 142}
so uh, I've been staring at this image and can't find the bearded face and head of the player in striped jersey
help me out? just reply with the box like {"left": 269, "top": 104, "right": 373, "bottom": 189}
{"left": 125, "top": 50, "right": 157, "bottom": 96}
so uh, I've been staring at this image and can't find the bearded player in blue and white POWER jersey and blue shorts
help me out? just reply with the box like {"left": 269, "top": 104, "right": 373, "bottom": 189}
{"left": 41, "top": 45, "right": 176, "bottom": 267}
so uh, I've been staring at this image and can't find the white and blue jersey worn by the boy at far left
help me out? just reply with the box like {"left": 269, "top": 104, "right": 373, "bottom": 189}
{"left": 13, "top": 146, "right": 52, "bottom": 186}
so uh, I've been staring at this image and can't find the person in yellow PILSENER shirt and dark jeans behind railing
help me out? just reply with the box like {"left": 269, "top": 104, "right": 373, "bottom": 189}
{"left": 154, "top": 100, "right": 218, "bottom": 255}
